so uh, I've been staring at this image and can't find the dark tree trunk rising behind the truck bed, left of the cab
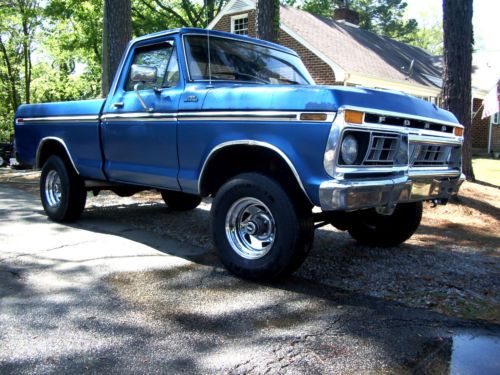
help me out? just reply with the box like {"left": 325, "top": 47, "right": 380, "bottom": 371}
{"left": 102, "top": 0, "right": 132, "bottom": 97}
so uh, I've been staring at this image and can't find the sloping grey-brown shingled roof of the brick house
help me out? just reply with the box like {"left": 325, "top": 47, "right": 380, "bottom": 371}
{"left": 280, "top": 6, "right": 441, "bottom": 87}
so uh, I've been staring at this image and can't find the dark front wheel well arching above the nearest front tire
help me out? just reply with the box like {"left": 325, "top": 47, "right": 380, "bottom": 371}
{"left": 200, "top": 145, "right": 310, "bottom": 206}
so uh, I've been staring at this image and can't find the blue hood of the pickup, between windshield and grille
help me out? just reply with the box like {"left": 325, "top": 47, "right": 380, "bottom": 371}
{"left": 203, "top": 85, "right": 458, "bottom": 123}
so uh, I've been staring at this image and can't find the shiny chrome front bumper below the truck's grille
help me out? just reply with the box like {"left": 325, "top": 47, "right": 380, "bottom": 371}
{"left": 319, "top": 171, "right": 465, "bottom": 213}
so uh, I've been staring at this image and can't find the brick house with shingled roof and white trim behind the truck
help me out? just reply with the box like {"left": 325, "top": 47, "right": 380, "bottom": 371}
{"left": 208, "top": 0, "right": 500, "bottom": 152}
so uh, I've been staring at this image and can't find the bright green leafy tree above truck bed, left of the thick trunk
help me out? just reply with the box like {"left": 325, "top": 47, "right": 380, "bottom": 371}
{"left": 42, "top": 0, "right": 103, "bottom": 102}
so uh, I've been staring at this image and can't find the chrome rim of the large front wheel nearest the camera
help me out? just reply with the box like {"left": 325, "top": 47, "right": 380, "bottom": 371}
{"left": 226, "top": 197, "right": 276, "bottom": 260}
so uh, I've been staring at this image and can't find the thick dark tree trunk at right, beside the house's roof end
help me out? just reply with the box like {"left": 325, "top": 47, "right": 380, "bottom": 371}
{"left": 442, "top": 0, "right": 474, "bottom": 181}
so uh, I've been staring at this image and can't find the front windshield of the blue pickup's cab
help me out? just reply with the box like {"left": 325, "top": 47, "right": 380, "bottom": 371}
{"left": 185, "top": 35, "right": 312, "bottom": 85}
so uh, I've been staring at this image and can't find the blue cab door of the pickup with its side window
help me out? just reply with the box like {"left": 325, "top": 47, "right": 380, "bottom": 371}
{"left": 102, "top": 39, "right": 183, "bottom": 190}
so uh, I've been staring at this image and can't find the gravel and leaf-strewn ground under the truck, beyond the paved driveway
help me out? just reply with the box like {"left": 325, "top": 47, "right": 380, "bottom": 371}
{"left": 0, "top": 167, "right": 500, "bottom": 323}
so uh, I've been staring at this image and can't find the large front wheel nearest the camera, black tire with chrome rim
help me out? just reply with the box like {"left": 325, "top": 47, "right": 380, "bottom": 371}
{"left": 211, "top": 173, "right": 314, "bottom": 281}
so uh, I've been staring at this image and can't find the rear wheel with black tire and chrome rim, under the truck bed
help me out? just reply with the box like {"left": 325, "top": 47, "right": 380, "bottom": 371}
{"left": 40, "top": 155, "right": 87, "bottom": 223}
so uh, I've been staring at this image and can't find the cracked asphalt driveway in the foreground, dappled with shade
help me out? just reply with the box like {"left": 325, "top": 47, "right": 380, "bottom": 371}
{"left": 0, "top": 184, "right": 500, "bottom": 374}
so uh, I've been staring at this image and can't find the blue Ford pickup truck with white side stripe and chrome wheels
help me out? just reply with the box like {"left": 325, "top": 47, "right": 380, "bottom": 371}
{"left": 15, "top": 28, "right": 463, "bottom": 280}
